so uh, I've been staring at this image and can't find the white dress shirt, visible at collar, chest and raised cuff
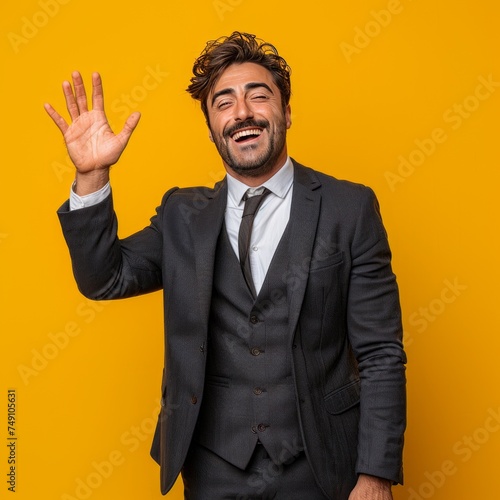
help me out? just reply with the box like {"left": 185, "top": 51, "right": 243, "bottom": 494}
{"left": 69, "top": 157, "right": 293, "bottom": 293}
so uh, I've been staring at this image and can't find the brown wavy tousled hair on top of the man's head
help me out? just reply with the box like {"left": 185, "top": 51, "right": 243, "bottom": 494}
{"left": 186, "top": 31, "right": 291, "bottom": 122}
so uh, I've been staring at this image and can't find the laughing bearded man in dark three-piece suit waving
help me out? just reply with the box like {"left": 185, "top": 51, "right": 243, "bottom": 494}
{"left": 46, "top": 32, "right": 405, "bottom": 500}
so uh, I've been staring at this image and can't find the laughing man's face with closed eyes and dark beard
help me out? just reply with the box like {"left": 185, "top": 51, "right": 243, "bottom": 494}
{"left": 207, "top": 63, "right": 291, "bottom": 177}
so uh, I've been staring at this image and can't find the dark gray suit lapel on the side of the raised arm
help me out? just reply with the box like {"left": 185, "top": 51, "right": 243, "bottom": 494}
{"left": 191, "top": 179, "right": 227, "bottom": 324}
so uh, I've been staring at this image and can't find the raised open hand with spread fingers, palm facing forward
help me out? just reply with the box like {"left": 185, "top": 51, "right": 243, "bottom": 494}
{"left": 45, "top": 71, "right": 141, "bottom": 194}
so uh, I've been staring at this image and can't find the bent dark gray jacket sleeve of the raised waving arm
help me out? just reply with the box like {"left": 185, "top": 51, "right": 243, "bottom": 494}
{"left": 57, "top": 188, "right": 175, "bottom": 300}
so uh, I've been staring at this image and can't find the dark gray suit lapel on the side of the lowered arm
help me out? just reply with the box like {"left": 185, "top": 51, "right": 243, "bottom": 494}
{"left": 284, "top": 161, "right": 321, "bottom": 339}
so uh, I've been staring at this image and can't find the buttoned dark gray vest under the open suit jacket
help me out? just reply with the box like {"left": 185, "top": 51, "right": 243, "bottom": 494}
{"left": 195, "top": 227, "right": 302, "bottom": 469}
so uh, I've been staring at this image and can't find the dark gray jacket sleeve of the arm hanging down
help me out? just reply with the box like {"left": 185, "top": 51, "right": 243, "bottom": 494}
{"left": 347, "top": 189, "right": 406, "bottom": 483}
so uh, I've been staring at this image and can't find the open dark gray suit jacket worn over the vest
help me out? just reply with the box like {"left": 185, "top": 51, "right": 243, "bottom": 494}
{"left": 59, "top": 162, "right": 406, "bottom": 498}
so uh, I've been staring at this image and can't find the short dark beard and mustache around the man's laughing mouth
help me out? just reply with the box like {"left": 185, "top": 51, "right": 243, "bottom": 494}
{"left": 214, "top": 116, "right": 286, "bottom": 177}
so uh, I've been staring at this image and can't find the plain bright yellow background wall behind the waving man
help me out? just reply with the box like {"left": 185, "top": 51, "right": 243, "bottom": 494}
{"left": 0, "top": 0, "right": 500, "bottom": 500}
